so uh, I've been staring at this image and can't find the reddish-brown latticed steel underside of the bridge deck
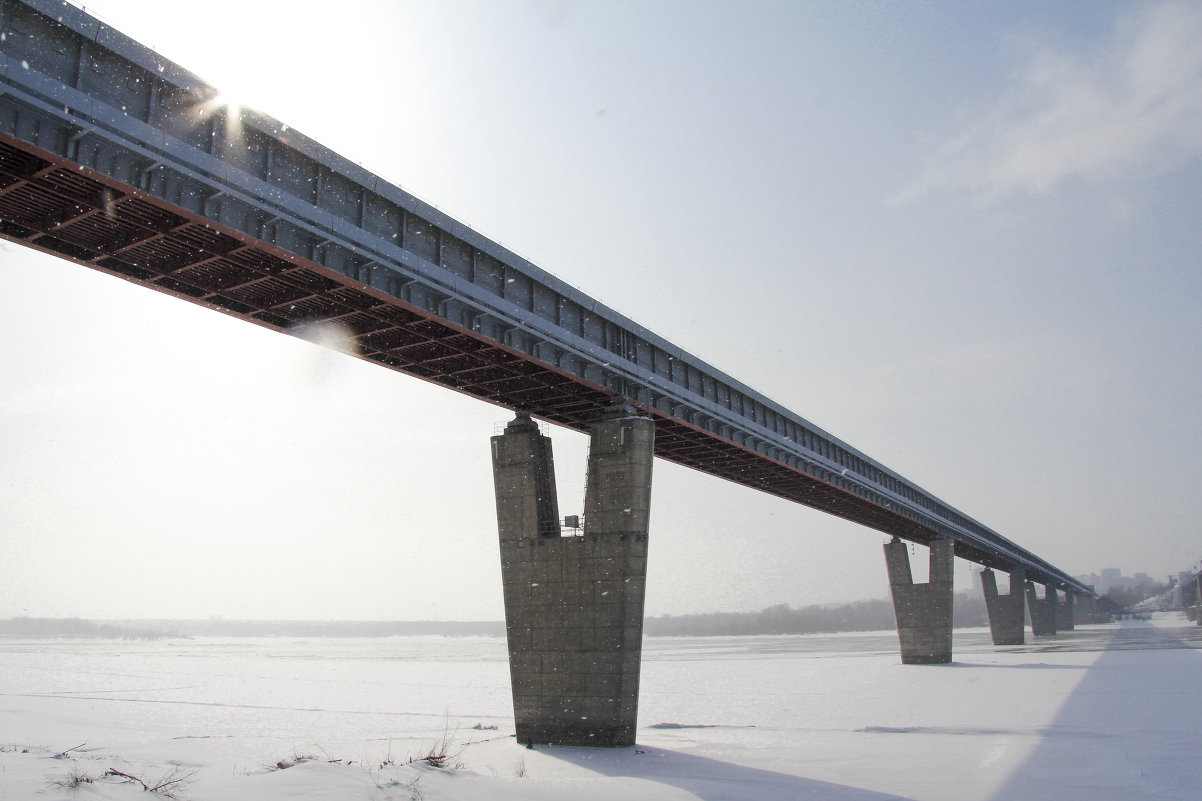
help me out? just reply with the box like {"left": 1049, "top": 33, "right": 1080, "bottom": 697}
{"left": 0, "top": 135, "right": 1011, "bottom": 560}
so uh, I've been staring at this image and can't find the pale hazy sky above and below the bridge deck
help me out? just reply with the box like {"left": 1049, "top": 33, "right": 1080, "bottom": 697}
{"left": 0, "top": 0, "right": 1202, "bottom": 619}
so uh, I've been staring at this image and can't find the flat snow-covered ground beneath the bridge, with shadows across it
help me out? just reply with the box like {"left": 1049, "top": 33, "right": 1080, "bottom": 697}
{"left": 0, "top": 613, "right": 1202, "bottom": 801}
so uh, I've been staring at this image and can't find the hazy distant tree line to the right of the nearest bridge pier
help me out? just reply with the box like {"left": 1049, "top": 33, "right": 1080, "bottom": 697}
{"left": 643, "top": 593, "right": 989, "bottom": 636}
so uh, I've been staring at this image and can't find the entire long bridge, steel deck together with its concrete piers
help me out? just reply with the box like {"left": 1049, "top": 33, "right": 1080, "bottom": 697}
{"left": 0, "top": 0, "right": 1093, "bottom": 744}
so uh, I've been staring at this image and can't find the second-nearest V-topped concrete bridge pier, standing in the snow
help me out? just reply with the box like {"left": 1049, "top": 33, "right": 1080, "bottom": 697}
{"left": 885, "top": 538, "right": 956, "bottom": 665}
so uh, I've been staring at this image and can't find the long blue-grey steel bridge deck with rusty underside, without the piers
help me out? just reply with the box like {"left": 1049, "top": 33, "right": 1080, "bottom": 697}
{"left": 0, "top": 0, "right": 1093, "bottom": 595}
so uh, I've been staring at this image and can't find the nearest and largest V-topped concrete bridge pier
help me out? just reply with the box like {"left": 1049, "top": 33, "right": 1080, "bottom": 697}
{"left": 493, "top": 405, "right": 655, "bottom": 747}
